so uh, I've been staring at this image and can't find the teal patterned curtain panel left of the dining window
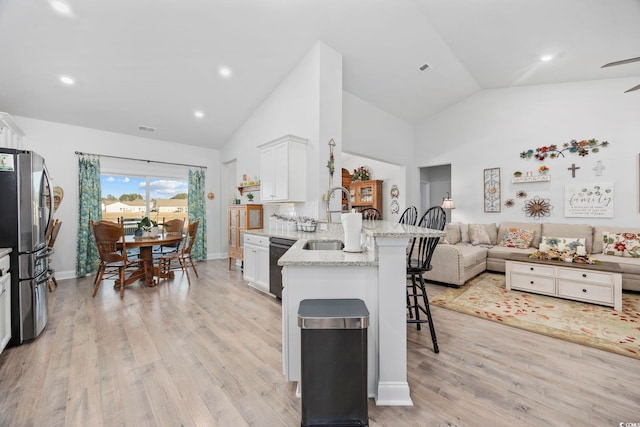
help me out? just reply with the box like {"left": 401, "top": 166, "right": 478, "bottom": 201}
{"left": 76, "top": 156, "right": 102, "bottom": 277}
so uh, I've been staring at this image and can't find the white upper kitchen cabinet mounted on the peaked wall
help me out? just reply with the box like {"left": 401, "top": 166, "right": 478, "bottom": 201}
{"left": 258, "top": 135, "right": 307, "bottom": 203}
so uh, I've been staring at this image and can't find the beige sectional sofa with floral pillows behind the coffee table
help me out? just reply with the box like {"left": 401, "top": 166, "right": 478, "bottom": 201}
{"left": 424, "top": 222, "right": 640, "bottom": 292}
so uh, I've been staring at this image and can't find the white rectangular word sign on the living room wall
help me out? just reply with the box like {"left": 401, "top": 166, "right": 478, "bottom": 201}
{"left": 564, "top": 182, "right": 613, "bottom": 218}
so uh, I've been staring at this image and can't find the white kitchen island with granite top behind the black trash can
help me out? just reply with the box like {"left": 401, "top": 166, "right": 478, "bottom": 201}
{"left": 278, "top": 221, "right": 444, "bottom": 406}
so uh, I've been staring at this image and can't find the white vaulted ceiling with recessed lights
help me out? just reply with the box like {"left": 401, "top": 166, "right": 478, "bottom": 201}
{"left": 0, "top": 0, "right": 640, "bottom": 148}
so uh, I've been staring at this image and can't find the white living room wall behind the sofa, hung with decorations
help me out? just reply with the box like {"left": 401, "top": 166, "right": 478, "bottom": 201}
{"left": 415, "top": 78, "right": 640, "bottom": 229}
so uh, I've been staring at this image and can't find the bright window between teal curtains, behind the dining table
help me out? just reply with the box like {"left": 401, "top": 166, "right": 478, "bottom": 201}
{"left": 100, "top": 173, "right": 189, "bottom": 224}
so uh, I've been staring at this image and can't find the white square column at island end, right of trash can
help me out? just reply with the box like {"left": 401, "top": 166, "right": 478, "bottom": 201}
{"left": 376, "top": 237, "right": 413, "bottom": 406}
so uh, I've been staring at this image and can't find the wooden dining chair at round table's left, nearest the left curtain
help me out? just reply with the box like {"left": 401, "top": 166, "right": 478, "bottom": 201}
{"left": 89, "top": 220, "right": 144, "bottom": 298}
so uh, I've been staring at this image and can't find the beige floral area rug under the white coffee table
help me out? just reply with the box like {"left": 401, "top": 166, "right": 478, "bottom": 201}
{"left": 431, "top": 272, "right": 640, "bottom": 359}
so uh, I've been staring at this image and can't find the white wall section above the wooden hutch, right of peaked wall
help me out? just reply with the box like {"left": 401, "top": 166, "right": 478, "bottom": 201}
{"left": 344, "top": 91, "right": 420, "bottom": 211}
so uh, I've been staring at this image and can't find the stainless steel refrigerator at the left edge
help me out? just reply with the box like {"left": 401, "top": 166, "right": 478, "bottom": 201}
{"left": 0, "top": 148, "right": 53, "bottom": 345}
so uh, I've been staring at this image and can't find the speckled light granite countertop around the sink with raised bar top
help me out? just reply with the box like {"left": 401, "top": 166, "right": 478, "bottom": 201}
{"left": 245, "top": 220, "right": 445, "bottom": 267}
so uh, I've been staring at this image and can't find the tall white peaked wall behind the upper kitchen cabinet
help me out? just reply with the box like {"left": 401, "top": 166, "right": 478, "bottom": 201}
{"left": 222, "top": 42, "right": 342, "bottom": 224}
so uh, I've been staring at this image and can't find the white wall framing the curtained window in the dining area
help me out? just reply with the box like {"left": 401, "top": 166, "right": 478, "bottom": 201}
{"left": 14, "top": 117, "right": 226, "bottom": 280}
